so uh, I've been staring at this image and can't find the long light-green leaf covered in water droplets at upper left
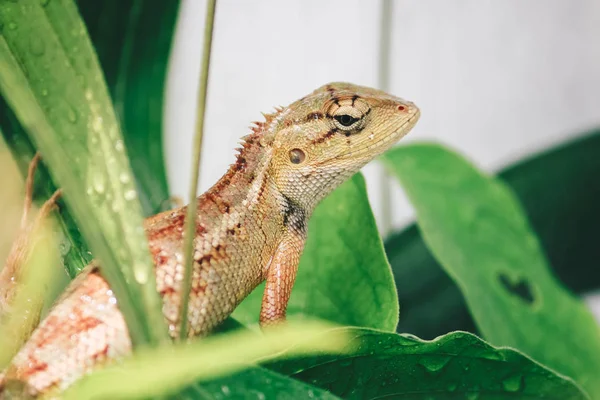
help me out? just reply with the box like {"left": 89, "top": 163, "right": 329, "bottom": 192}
{"left": 0, "top": 0, "right": 168, "bottom": 344}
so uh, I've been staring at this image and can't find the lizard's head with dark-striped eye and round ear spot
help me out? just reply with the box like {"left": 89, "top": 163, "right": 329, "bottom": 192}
{"left": 263, "top": 83, "right": 419, "bottom": 210}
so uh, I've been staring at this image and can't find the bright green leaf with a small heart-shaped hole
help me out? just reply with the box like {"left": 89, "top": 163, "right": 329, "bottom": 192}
{"left": 384, "top": 144, "right": 600, "bottom": 397}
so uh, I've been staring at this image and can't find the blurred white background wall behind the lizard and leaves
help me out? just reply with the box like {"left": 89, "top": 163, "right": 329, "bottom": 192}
{"left": 165, "top": 0, "right": 600, "bottom": 318}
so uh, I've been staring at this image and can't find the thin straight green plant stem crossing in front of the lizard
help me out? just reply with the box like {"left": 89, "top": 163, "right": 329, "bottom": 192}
{"left": 179, "top": 0, "right": 217, "bottom": 340}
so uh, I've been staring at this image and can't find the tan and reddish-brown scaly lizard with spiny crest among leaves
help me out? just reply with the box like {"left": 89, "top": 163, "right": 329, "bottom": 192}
{"left": 1, "top": 82, "right": 420, "bottom": 397}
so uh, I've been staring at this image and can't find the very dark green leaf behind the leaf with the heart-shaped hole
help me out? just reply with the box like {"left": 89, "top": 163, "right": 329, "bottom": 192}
{"left": 385, "top": 131, "right": 600, "bottom": 339}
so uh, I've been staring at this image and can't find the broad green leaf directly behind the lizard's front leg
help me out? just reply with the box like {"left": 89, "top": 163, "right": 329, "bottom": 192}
{"left": 233, "top": 174, "right": 398, "bottom": 331}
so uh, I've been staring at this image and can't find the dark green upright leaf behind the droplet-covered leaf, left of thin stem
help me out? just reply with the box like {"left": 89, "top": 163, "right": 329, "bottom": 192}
{"left": 78, "top": 0, "right": 180, "bottom": 216}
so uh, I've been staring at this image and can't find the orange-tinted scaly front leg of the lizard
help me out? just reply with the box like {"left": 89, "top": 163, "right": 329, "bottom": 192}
{"left": 260, "top": 230, "right": 306, "bottom": 326}
